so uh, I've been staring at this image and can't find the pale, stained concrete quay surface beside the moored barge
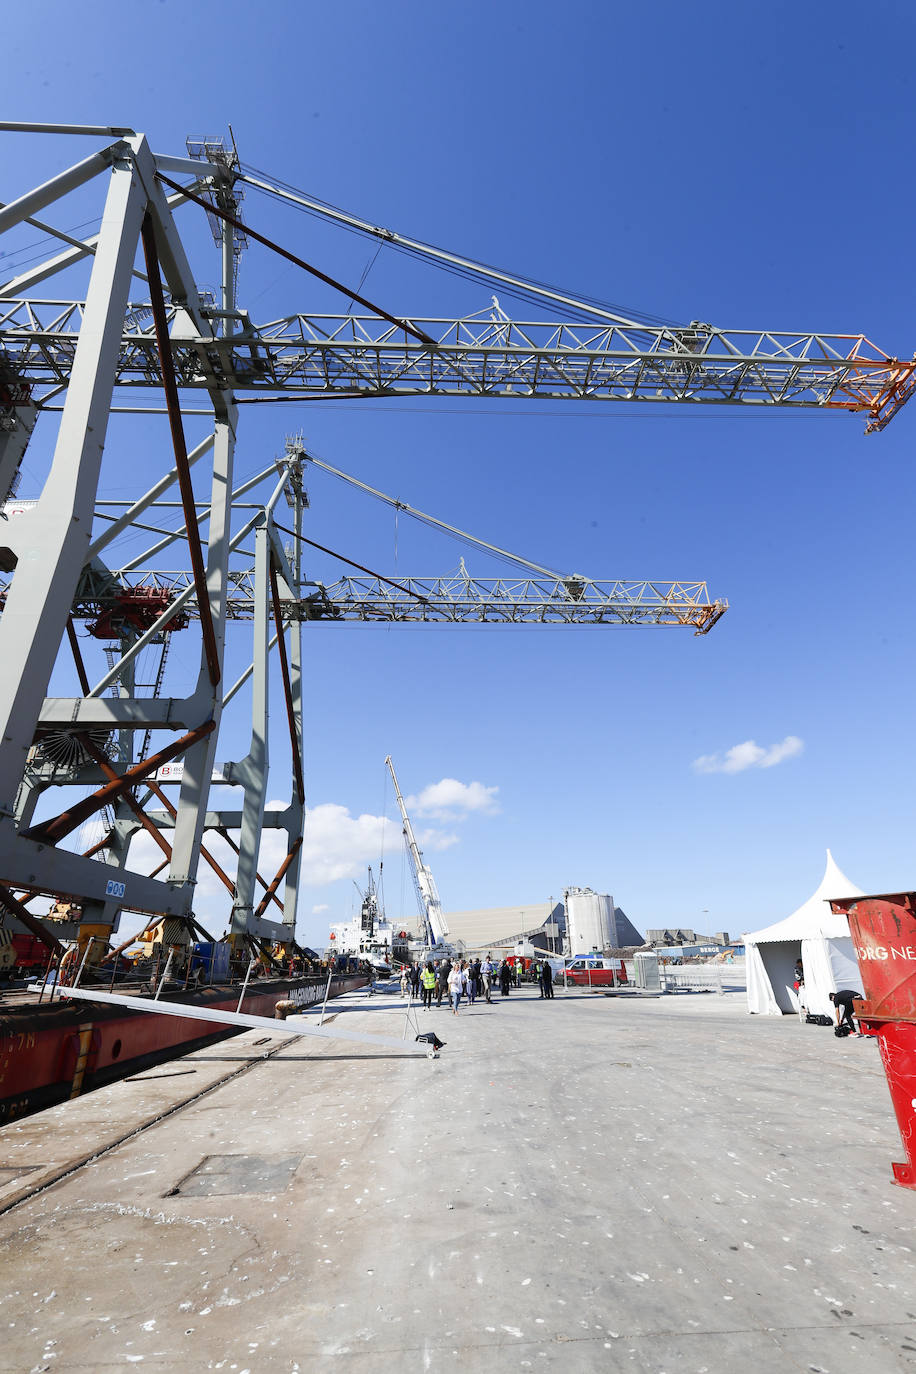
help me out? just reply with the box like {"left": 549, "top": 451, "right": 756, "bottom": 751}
{"left": 0, "top": 989, "right": 916, "bottom": 1374}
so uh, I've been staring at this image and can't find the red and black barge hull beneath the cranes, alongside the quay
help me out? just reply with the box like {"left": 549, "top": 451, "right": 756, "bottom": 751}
{"left": 0, "top": 976, "right": 368, "bottom": 1125}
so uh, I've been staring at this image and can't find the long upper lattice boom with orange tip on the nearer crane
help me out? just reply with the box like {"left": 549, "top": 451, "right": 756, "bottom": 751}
{"left": 0, "top": 300, "right": 916, "bottom": 431}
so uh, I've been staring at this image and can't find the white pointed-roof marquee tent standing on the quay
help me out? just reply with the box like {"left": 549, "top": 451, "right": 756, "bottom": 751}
{"left": 744, "top": 849, "right": 862, "bottom": 1017}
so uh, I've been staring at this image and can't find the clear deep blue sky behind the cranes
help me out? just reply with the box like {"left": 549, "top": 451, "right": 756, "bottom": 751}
{"left": 0, "top": 0, "right": 916, "bottom": 943}
